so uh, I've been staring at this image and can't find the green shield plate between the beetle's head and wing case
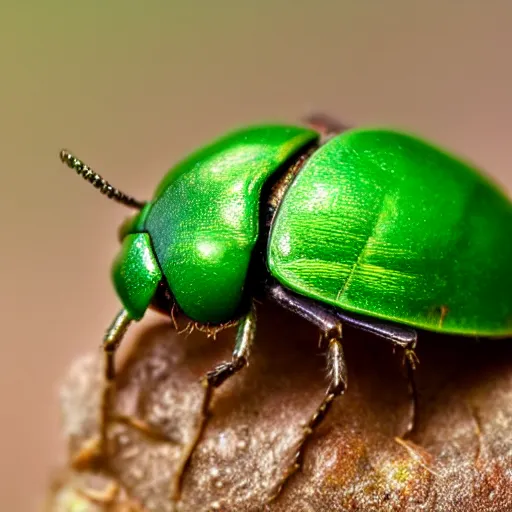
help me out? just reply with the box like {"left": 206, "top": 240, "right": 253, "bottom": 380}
{"left": 140, "top": 125, "right": 318, "bottom": 323}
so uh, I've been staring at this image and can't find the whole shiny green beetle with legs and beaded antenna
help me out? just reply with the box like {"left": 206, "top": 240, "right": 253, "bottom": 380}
{"left": 61, "top": 116, "right": 512, "bottom": 500}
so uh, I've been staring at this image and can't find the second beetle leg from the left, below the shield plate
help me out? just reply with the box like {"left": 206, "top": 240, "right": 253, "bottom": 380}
{"left": 171, "top": 306, "right": 256, "bottom": 501}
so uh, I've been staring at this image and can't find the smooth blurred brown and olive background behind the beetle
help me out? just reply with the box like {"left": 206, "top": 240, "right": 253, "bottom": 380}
{"left": 0, "top": 0, "right": 512, "bottom": 512}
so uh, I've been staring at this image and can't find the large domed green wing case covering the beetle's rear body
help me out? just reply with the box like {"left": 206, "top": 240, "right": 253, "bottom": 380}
{"left": 268, "top": 129, "right": 512, "bottom": 336}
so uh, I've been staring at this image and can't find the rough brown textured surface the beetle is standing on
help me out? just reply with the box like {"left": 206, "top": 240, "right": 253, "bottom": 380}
{"left": 47, "top": 306, "right": 512, "bottom": 512}
